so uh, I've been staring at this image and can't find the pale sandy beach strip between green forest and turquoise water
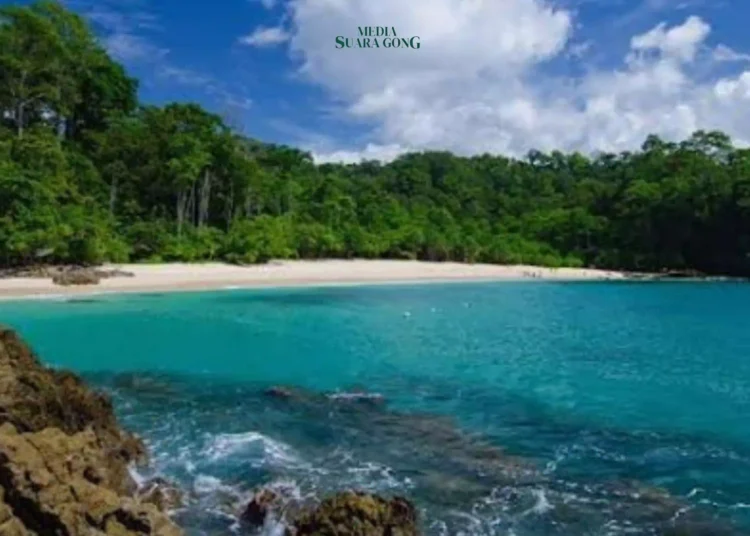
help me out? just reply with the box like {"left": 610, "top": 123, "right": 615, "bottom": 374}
{"left": 0, "top": 260, "right": 626, "bottom": 299}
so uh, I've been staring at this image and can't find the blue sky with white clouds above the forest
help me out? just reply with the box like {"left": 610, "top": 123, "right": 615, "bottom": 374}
{"left": 5, "top": 0, "right": 750, "bottom": 162}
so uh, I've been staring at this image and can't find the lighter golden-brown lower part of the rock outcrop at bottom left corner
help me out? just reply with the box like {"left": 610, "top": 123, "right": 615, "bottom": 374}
{"left": 0, "top": 423, "right": 181, "bottom": 536}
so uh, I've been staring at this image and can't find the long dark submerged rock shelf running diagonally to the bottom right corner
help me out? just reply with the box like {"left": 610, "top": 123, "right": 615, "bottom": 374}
{"left": 254, "top": 387, "right": 739, "bottom": 536}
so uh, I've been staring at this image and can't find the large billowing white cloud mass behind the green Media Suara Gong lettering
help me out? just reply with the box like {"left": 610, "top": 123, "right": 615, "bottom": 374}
{"left": 278, "top": 0, "right": 750, "bottom": 161}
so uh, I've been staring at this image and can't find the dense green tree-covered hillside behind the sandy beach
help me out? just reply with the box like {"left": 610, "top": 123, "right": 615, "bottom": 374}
{"left": 0, "top": 1, "right": 750, "bottom": 275}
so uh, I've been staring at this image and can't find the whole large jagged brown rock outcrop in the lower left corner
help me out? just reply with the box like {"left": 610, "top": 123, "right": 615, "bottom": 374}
{"left": 0, "top": 327, "right": 181, "bottom": 536}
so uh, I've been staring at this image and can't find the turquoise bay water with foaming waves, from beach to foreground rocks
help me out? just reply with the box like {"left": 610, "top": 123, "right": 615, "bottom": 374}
{"left": 0, "top": 281, "right": 750, "bottom": 536}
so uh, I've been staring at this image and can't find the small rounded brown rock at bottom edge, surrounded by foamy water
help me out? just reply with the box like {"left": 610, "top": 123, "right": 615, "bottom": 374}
{"left": 293, "top": 491, "right": 419, "bottom": 536}
